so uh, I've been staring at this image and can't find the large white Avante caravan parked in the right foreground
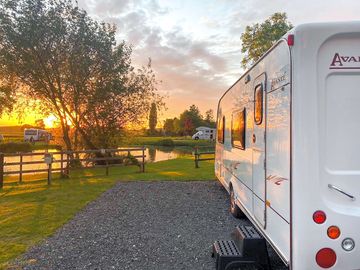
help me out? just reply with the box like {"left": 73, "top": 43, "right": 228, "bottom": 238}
{"left": 215, "top": 22, "right": 360, "bottom": 270}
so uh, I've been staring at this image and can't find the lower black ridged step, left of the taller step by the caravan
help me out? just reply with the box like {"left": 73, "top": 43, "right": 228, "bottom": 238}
{"left": 212, "top": 240, "right": 255, "bottom": 270}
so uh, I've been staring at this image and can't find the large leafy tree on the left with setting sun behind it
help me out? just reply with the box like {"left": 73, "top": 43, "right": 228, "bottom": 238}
{"left": 0, "top": 0, "right": 161, "bottom": 149}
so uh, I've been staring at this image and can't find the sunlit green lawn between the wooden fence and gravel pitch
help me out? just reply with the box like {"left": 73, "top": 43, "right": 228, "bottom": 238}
{"left": 0, "top": 156, "right": 215, "bottom": 269}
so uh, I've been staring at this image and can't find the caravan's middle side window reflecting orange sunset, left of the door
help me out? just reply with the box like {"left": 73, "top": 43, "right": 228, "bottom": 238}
{"left": 231, "top": 108, "right": 246, "bottom": 150}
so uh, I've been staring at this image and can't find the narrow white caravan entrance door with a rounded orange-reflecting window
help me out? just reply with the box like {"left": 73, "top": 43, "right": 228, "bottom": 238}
{"left": 252, "top": 73, "right": 266, "bottom": 227}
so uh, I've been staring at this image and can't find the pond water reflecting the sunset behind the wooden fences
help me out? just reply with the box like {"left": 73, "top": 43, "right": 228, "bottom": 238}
{"left": 4, "top": 146, "right": 213, "bottom": 172}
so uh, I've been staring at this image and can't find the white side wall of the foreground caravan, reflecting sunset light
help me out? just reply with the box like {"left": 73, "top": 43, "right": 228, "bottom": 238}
{"left": 215, "top": 41, "right": 290, "bottom": 262}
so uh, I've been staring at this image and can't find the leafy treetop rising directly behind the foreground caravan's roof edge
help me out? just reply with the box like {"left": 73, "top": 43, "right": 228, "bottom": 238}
{"left": 241, "top": 12, "right": 293, "bottom": 68}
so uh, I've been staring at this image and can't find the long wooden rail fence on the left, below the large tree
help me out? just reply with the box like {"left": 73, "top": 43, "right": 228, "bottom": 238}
{"left": 0, "top": 147, "right": 146, "bottom": 189}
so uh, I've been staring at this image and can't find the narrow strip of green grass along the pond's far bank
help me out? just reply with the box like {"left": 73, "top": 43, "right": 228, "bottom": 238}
{"left": 121, "top": 137, "right": 215, "bottom": 147}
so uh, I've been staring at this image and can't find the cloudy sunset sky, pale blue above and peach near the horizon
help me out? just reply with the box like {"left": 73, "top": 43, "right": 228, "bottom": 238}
{"left": 0, "top": 0, "right": 360, "bottom": 125}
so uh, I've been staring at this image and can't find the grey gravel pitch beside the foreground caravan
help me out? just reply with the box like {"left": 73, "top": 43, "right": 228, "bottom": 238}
{"left": 15, "top": 181, "right": 286, "bottom": 270}
